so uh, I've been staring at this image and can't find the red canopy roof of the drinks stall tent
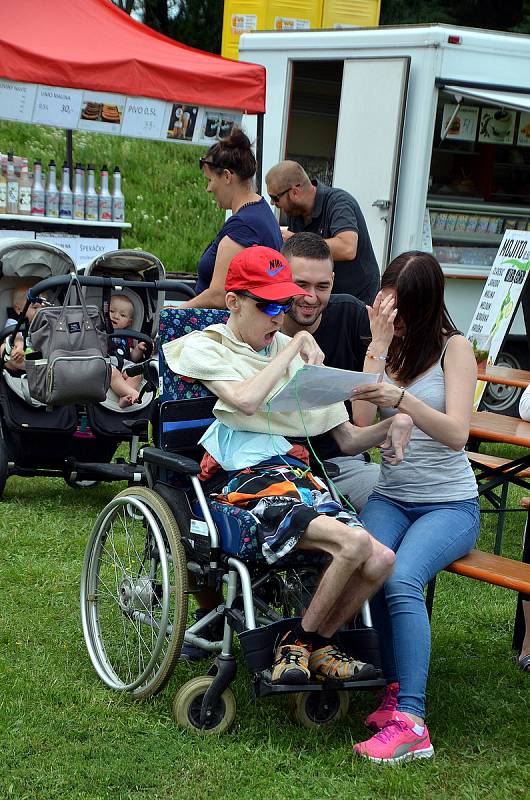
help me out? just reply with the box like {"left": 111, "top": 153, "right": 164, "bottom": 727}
{"left": 0, "top": 0, "right": 265, "bottom": 114}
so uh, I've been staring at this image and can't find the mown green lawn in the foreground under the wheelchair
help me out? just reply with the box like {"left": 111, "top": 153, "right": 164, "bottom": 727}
{"left": 0, "top": 444, "right": 530, "bottom": 800}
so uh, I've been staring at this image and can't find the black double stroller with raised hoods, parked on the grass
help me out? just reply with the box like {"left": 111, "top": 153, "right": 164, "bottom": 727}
{"left": 0, "top": 239, "right": 171, "bottom": 496}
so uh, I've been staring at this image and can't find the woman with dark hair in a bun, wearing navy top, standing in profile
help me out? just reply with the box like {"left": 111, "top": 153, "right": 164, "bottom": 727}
{"left": 182, "top": 128, "right": 283, "bottom": 308}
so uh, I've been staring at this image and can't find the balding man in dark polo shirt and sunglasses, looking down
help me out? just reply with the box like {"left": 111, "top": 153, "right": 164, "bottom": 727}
{"left": 265, "top": 161, "right": 380, "bottom": 303}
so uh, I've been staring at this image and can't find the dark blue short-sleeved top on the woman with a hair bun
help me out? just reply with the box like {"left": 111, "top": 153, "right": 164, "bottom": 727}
{"left": 195, "top": 197, "right": 283, "bottom": 294}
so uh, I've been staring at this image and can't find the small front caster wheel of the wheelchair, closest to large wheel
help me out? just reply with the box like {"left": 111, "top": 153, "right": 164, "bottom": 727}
{"left": 173, "top": 675, "right": 236, "bottom": 734}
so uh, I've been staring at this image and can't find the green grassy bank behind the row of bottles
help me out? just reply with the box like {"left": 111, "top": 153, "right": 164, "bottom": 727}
{"left": 0, "top": 121, "right": 224, "bottom": 272}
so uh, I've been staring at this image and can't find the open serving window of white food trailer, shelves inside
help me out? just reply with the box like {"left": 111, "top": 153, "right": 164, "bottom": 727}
{"left": 427, "top": 91, "right": 530, "bottom": 278}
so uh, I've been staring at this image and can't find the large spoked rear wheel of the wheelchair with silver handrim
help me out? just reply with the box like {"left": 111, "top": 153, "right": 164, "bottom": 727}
{"left": 81, "top": 487, "right": 188, "bottom": 699}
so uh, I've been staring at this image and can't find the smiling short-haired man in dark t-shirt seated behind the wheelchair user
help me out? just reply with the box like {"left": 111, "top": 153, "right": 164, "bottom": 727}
{"left": 282, "top": 233, "right": 379, "bottom": 510}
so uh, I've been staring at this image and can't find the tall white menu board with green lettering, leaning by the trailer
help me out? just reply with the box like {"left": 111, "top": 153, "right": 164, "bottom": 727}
{"left": 467, "top": 230, "right": 530, "bottom": 411}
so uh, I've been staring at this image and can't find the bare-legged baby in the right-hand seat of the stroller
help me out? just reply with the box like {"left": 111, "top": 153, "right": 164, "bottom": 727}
{"left": 109, "top": 294, "right": 146, "bottom": 408}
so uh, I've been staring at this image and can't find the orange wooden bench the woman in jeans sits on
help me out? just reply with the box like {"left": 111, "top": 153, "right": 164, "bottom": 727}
{"left": 425, "top": 550, "right": 530, "bottom": 618}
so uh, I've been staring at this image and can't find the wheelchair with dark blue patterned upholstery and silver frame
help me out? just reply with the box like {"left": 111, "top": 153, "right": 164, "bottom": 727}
{"left": 80, "top": 309, "right": 385, "bottom": 733}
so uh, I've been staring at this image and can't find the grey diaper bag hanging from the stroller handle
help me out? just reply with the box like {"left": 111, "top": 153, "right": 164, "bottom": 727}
{"left": 25, "top": 276, "right": 111, "bottom": 406}
